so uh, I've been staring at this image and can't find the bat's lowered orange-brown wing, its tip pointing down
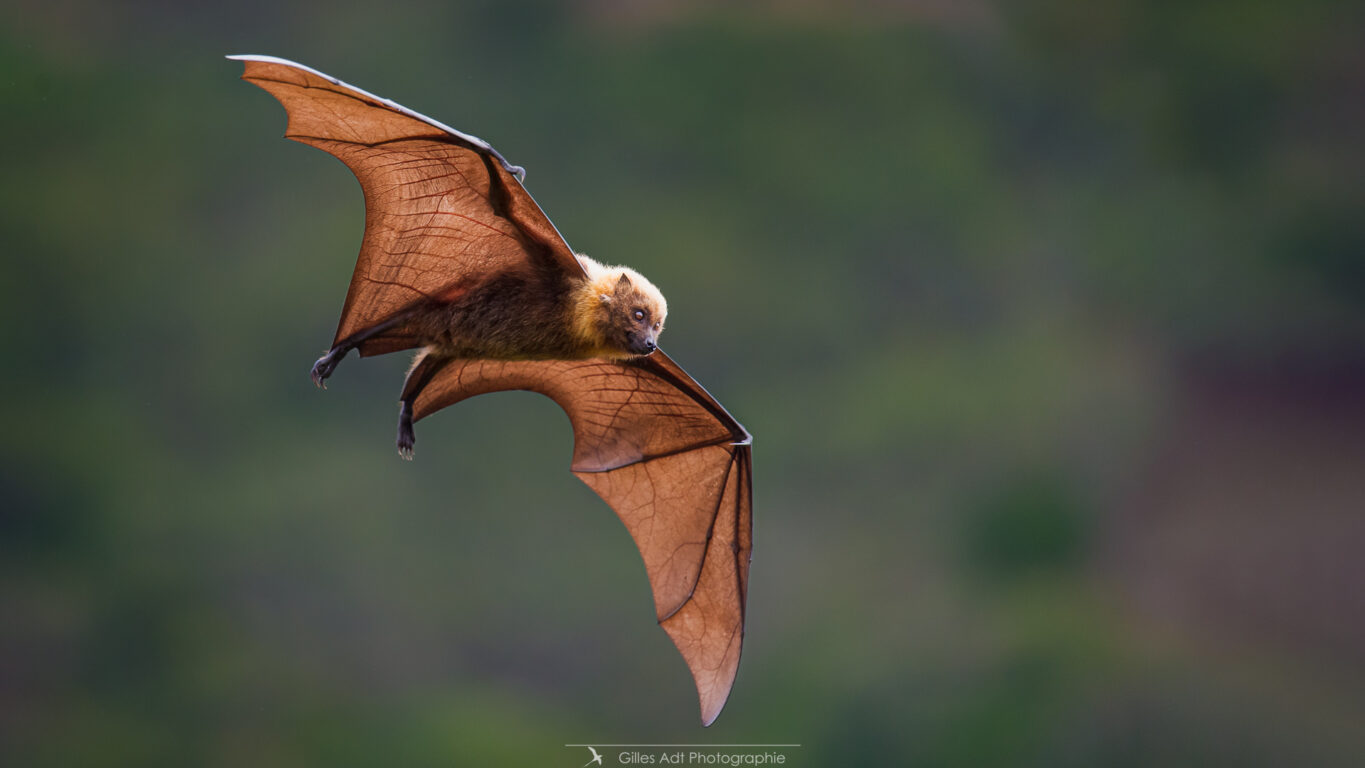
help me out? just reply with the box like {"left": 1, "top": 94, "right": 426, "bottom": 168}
{"left": 414, "top": 351, "right": 752, "bottom": 724}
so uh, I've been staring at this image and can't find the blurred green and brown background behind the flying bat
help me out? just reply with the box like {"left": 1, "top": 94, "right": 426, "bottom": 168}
{"left": 0, "top": 0, "right": 1365, "bottom": 768}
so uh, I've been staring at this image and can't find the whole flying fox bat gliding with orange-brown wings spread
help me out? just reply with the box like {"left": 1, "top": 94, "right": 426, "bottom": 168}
{"left": 229, "top": 56, "right": 752, "bottom": 726}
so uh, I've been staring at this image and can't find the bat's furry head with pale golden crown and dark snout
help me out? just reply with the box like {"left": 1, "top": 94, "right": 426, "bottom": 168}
{"left": 575, "top": 256, "right": 669, "bottom": 357}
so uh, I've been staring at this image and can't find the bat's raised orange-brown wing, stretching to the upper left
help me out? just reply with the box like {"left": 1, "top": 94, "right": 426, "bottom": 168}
{"left": 229, "top": 56, "right": 583, "bottom": 355}
